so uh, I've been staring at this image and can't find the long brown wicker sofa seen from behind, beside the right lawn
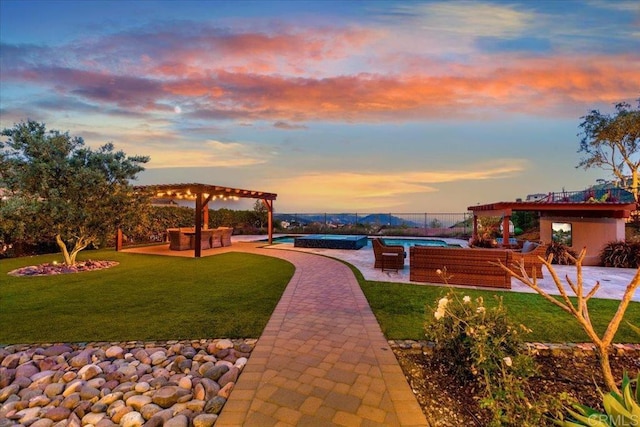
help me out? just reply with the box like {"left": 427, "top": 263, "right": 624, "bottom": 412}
{"left": 409, "top": 246, "right": 512, "bottom": 289}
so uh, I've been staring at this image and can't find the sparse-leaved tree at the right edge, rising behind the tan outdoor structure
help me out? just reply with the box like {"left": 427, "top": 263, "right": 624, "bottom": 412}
{"left": 577, "top": 99, "right": 640, "bottom": 202}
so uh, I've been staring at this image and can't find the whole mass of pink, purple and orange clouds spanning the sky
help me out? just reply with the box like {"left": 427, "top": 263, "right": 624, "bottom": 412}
{"left": 3, "top": 23, "right": 640, "bottom": 123}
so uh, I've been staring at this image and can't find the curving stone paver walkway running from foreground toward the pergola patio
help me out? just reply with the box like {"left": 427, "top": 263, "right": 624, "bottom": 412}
{"left": 210, "top": 249, "right": 427, "bottom": 427}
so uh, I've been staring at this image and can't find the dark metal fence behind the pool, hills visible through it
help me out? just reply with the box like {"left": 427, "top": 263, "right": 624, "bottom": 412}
{"left": 274, "top": 212, "right": 473, "bottom": 237}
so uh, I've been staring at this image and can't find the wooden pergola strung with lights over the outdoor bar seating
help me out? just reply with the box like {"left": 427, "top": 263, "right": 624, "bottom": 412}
{"left": 116, "top": 183, "right": 278, "bottom": 258}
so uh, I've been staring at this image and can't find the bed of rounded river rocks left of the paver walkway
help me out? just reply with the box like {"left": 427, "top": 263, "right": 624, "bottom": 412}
{"left": 0, "top": 339, "right": 257, "bottom": 427}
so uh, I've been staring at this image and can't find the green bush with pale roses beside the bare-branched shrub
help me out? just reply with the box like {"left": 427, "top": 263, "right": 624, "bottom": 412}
{"left": 425, "top": 290, "right": 556, "bottom": 426}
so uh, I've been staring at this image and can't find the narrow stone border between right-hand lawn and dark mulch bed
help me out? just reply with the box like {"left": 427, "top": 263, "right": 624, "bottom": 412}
{"left": 389, "top": 340, "right": 640, "bottom": 357}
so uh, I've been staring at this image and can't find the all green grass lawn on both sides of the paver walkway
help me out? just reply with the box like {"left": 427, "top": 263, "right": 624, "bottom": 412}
{"left": 0, "top": 250, "right": 640, "bottom": 344}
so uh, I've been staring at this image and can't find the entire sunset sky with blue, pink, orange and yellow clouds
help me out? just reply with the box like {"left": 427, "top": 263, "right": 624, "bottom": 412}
{"left": 0, "top": 0, "right": 640, "bottom": 213}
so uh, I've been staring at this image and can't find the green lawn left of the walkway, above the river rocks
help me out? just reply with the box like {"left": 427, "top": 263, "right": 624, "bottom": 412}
{"left": 0, "top": 250, "right": 294, "bottom": 344}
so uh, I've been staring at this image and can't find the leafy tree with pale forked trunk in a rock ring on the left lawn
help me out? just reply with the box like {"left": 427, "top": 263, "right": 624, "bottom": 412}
{"left": 0, "top": 121, "right": 149, "bottom": 265}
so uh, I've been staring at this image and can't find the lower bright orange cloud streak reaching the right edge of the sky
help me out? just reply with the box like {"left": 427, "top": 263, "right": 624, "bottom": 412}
{"left": 156, "top": 55, "right": 640, "bottom": 121}
